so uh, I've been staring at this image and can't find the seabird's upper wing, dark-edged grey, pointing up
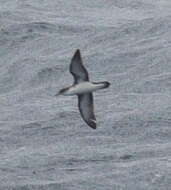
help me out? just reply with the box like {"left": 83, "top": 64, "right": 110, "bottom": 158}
{"left": 70, "top": 49, "right": 89, "bottom": 84}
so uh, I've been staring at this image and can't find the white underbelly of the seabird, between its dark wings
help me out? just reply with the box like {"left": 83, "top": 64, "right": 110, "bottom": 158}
{"left": 66, "top": 82, "right": 102, "bottom": 95}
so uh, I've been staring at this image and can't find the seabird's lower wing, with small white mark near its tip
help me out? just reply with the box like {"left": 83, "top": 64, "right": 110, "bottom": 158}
{"left": 78, "top": 93, "right": 96, "bottom": 129}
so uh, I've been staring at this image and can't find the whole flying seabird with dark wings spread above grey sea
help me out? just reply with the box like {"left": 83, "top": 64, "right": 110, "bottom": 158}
{"left": 56, "top": 49, "right": 110, "bottom": 129}
